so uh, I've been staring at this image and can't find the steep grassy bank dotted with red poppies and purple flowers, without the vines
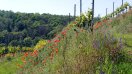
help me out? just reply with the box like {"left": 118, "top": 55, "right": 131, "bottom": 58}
{"left": 18, "top": 11, "right": 132, "bottom": 74}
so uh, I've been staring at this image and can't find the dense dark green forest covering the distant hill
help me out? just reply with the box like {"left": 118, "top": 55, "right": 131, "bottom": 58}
{"left": 0, "top": 10, "right": 74, "bottom": 47}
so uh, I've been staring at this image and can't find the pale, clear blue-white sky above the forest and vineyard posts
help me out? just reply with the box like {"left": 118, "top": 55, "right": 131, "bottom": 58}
{"left": 0, "top": 0, "right": 132, "bottom": 16}
